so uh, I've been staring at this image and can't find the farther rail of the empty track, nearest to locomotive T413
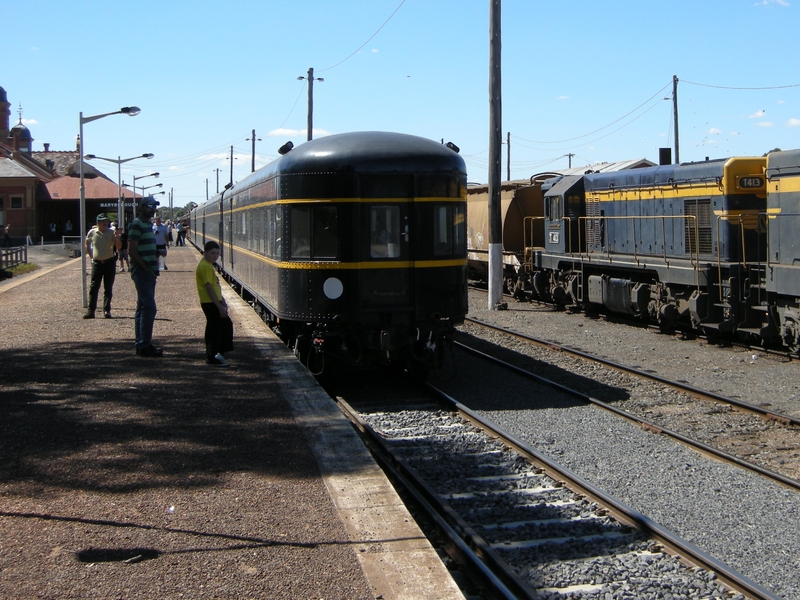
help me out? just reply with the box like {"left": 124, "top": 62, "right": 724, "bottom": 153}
{"left": 464, "top": 317, "right": 800, "bottom": 427}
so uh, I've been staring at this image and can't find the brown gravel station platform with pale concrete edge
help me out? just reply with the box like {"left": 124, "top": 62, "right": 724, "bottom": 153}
{"left": 0, "top": 246, "right": 462, "bottom": 600}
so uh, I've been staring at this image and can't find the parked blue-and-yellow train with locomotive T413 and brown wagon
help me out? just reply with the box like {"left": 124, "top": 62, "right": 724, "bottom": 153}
{"left": 468, "top": 150, "right": 800, "bottom": 353}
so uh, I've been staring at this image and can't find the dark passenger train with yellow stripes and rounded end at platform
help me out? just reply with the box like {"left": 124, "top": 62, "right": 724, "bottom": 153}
{"left": 190, "top": 132, "right": 467, "bottom": 373}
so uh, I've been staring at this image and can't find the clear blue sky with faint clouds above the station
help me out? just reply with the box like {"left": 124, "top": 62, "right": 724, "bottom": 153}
{"left": 0, "top": 0, "right": 800, "bottom": 207}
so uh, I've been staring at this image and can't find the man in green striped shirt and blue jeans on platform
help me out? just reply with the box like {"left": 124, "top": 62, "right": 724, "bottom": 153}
{"left": 128, "top": 198, "right": 164, "bottom": 356}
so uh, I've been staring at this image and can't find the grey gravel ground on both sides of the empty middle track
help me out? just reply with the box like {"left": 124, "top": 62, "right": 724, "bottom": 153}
{"left": 432, "top": 292, "right": 800, "bottom": 598}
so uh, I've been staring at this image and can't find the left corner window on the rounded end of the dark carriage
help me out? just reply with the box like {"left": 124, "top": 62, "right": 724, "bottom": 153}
{"left": 290, "top": 206, "right": 339, "bottom": 260}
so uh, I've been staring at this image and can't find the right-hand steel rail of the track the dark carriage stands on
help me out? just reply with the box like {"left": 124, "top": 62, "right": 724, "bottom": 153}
{"left": 428, "top": 384, "right": 780, "bottom": 600}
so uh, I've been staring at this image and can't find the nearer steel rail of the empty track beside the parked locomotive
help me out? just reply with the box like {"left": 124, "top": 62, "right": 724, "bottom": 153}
{"left": 454, "top": 342, "right": 800, "bottom": 491}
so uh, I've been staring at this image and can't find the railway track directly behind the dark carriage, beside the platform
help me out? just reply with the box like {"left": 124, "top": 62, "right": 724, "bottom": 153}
{"left": 329, "top": 372, "right": 777, "bottom": 598}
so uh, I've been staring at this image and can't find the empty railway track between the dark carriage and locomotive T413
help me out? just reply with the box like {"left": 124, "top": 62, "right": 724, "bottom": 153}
{"left": 458, "top": 318, "right": 800, "bottom": 491}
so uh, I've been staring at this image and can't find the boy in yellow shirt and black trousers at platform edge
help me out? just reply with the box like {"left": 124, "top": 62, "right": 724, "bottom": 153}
{"left": 195, "top": 242, "right": 233, "bottom": 367}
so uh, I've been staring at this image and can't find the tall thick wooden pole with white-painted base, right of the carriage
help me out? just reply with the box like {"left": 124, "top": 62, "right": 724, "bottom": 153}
{"left": 488, "top": 0, "right": 503, "bottom": 310}
